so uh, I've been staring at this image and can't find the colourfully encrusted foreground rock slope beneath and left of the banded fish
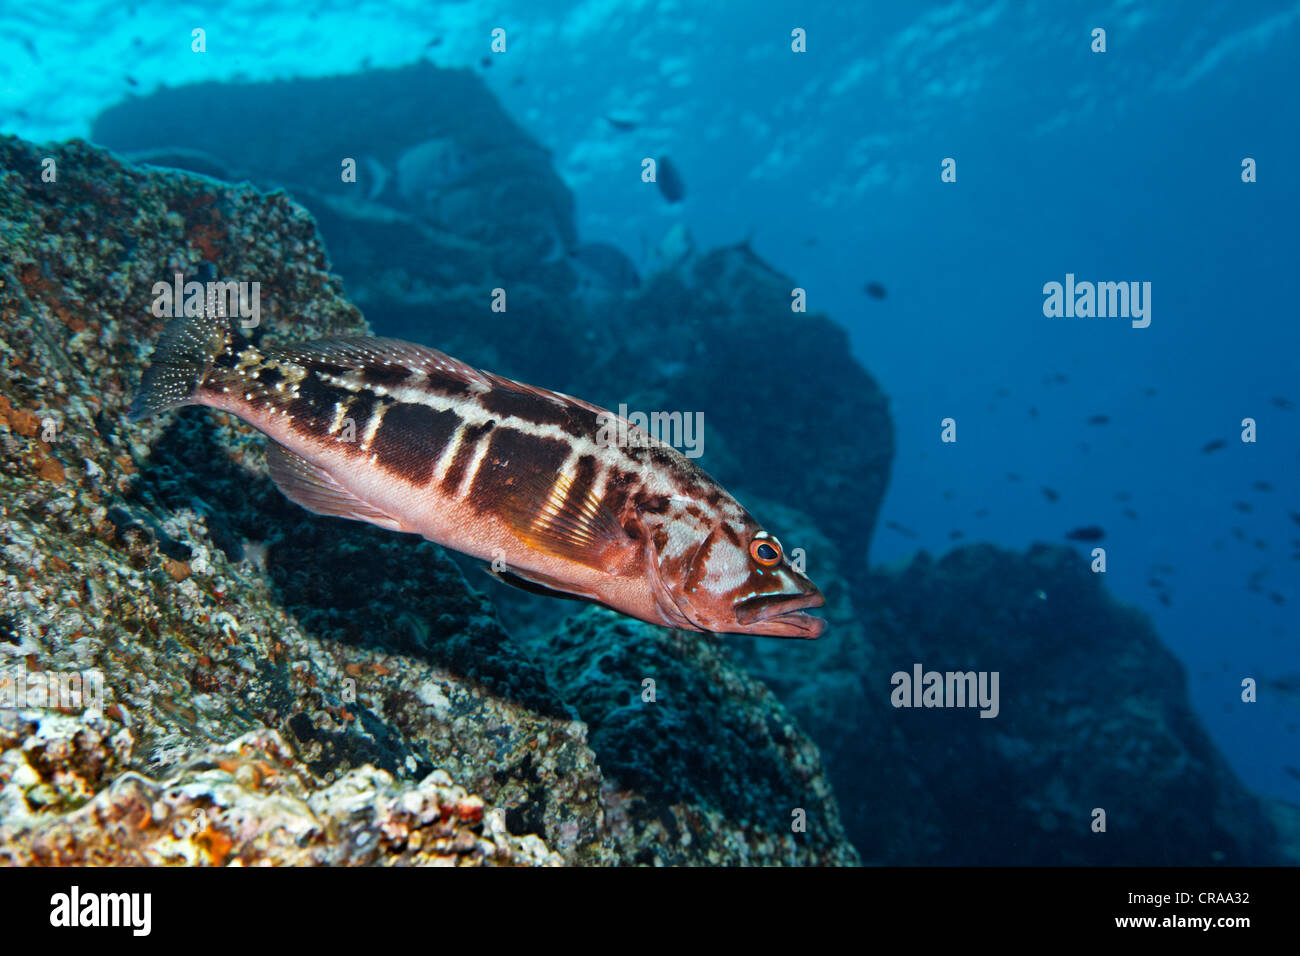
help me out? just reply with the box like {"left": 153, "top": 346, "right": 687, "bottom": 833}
{"left": 0, "top": 138, "right": 855, "bottom": 864}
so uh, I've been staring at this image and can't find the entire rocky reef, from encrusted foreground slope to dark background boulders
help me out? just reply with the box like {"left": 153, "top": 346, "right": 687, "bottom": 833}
{"left": 0, "top": 66, "right": 1300, "bottom": 865}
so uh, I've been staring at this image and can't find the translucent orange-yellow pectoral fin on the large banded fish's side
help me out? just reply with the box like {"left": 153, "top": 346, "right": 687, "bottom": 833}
{"left": 499, "top": 475, "right": 629, "bottom": 567}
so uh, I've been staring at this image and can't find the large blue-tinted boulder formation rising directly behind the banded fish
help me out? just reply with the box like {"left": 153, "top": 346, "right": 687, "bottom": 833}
{"left": 94, "top": 64, "right": 894, "bottom": 584}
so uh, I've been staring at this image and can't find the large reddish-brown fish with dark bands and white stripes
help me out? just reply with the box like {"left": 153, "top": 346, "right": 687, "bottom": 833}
{"left": 127, "top": 315, "right": 826, "bottom": 639}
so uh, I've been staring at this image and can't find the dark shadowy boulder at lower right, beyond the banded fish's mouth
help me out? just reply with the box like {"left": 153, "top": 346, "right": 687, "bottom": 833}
{"left": 781, "top": 544, "right": 1300, "bottom": 866}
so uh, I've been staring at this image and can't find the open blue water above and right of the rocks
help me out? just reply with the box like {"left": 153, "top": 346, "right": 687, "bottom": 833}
{"left": 0, "top": 0, "right": 1300, "bottom": 801}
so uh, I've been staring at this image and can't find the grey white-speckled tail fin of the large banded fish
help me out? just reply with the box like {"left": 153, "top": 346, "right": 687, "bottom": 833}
{"left": 127, "top": 315, "right": 242, "bottom": 421}
